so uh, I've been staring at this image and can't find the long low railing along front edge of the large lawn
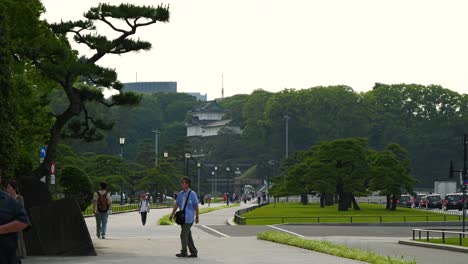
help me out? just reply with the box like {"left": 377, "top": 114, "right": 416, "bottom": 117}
{"left": 234, "top": 214, "right": 461, "bottom": 225}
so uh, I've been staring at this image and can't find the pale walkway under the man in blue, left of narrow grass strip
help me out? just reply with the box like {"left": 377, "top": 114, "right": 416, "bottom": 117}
{"left": 23, "top": 201, "right": 362, "bottom": 264}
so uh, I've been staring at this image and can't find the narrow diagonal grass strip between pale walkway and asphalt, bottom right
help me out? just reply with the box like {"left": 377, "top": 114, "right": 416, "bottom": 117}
{"left": 257, "top": 231, "right": 416, "bottom": 264}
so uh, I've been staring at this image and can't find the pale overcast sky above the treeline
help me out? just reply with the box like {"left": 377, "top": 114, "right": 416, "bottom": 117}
{"left": 42, "top": 0, "right": 468, "bottom": 99}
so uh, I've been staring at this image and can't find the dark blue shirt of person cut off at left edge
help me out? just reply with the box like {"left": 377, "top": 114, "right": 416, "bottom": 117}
{"left": 0, "top": 191, "right": 29, "bottom": 245}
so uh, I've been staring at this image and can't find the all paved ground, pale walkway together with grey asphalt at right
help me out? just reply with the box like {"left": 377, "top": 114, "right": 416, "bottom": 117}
{"left": 23, "top": 203, "right": 466, "bottom": 264}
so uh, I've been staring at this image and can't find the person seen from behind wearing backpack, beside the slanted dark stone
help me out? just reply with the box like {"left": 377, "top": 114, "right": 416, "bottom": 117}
{"left": 93, "top": 182, "right": 112, "bottom": 239}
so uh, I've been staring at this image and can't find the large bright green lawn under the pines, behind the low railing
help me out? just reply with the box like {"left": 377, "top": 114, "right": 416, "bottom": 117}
{"left": 242, "top": 203, "right": 459, "bottom": 225}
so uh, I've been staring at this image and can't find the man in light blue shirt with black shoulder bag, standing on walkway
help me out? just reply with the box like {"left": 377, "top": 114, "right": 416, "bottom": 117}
{"left": 169, "top": 177, "right": 199, "bottom": 258}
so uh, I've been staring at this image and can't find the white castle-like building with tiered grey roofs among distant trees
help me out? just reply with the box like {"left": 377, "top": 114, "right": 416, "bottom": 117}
{"left": 186, "top": 101, "right": 242, "bottom": 137}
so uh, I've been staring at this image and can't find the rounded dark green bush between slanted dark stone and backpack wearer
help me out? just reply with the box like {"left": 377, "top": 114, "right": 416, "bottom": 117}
{"left": 59, "top": 167, "right": 93, "bottom": 211}
